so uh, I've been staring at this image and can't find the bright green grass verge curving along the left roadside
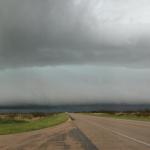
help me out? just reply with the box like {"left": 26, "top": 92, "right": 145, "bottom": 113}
{"left": 0, "top": 113, "right": 68, "bottom": 134}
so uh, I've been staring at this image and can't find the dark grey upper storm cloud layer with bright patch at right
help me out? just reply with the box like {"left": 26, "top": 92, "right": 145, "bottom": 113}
{"left": 0, "top": 0, "right": 150, "bottom": 68}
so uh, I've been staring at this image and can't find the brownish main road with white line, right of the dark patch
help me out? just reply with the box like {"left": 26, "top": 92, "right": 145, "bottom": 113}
{"left": 70, "top": 114, "right": 150, "bottom": 150}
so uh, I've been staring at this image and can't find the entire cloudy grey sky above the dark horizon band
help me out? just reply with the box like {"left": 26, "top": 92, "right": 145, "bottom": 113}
{"left": 0, "top": 0, "right": 150, "bottom": 105}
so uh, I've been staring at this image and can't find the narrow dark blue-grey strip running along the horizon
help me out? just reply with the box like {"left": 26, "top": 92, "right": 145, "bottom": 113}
{"left": 0, "top": 103, "right": 150, "bottom": 113}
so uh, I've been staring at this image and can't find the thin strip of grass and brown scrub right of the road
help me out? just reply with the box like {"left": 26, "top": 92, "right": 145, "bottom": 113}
{"left": 86, "top": 112, "right": 150, "bottom": 121}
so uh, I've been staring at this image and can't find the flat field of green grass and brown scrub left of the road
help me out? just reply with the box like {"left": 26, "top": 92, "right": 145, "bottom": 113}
{"left": 0, "top": 113, "right": 68, "bottom": 134}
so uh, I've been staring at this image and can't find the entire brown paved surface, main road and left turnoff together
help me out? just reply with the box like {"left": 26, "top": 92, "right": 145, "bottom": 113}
{"left": 0, "top": 113, "right": 150, "bottom": 150}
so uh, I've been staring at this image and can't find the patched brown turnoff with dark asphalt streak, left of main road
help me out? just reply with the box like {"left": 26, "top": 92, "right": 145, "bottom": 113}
{"left": 0, "top": 120, "right": 97, "bottom": 150}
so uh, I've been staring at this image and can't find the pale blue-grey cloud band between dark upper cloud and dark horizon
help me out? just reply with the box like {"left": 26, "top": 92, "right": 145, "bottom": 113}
{"left": 0, "top": 65, "right": 150, "bottom": 105}
